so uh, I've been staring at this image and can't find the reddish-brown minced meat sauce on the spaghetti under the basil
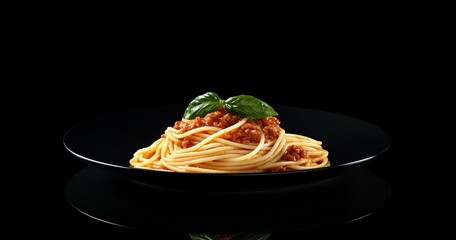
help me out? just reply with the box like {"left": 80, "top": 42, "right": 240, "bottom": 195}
{"left": 173, "top": 107, "right": 306, "bottom": 167}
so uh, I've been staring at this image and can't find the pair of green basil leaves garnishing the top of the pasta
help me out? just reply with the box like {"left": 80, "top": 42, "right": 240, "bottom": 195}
{"left": 184, "top": 92, "right": 278, "bottom": 119}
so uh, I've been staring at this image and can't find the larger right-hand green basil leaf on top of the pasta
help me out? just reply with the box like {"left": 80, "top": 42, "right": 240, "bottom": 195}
{"left": 225, "top": 95, "right": 278, "bottom": 119}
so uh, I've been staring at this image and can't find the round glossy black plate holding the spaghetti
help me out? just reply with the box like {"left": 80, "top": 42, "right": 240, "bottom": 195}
{"left": 63, "top": 104, "right": 391, "bottom": 188}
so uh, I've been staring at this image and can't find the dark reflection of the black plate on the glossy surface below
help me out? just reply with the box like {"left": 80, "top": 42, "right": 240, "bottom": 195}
{"left": 65, "top": 166, "right": 390, "bottom": 233}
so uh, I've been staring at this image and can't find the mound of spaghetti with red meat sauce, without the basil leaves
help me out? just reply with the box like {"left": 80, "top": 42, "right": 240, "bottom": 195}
{"left": 130, "top": 102, "right": 330, "bottom": 173}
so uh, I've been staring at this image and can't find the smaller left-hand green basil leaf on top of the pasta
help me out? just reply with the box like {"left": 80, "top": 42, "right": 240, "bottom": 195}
{"left": 183, "top": 92, "right": 224, "bottom": 119}
